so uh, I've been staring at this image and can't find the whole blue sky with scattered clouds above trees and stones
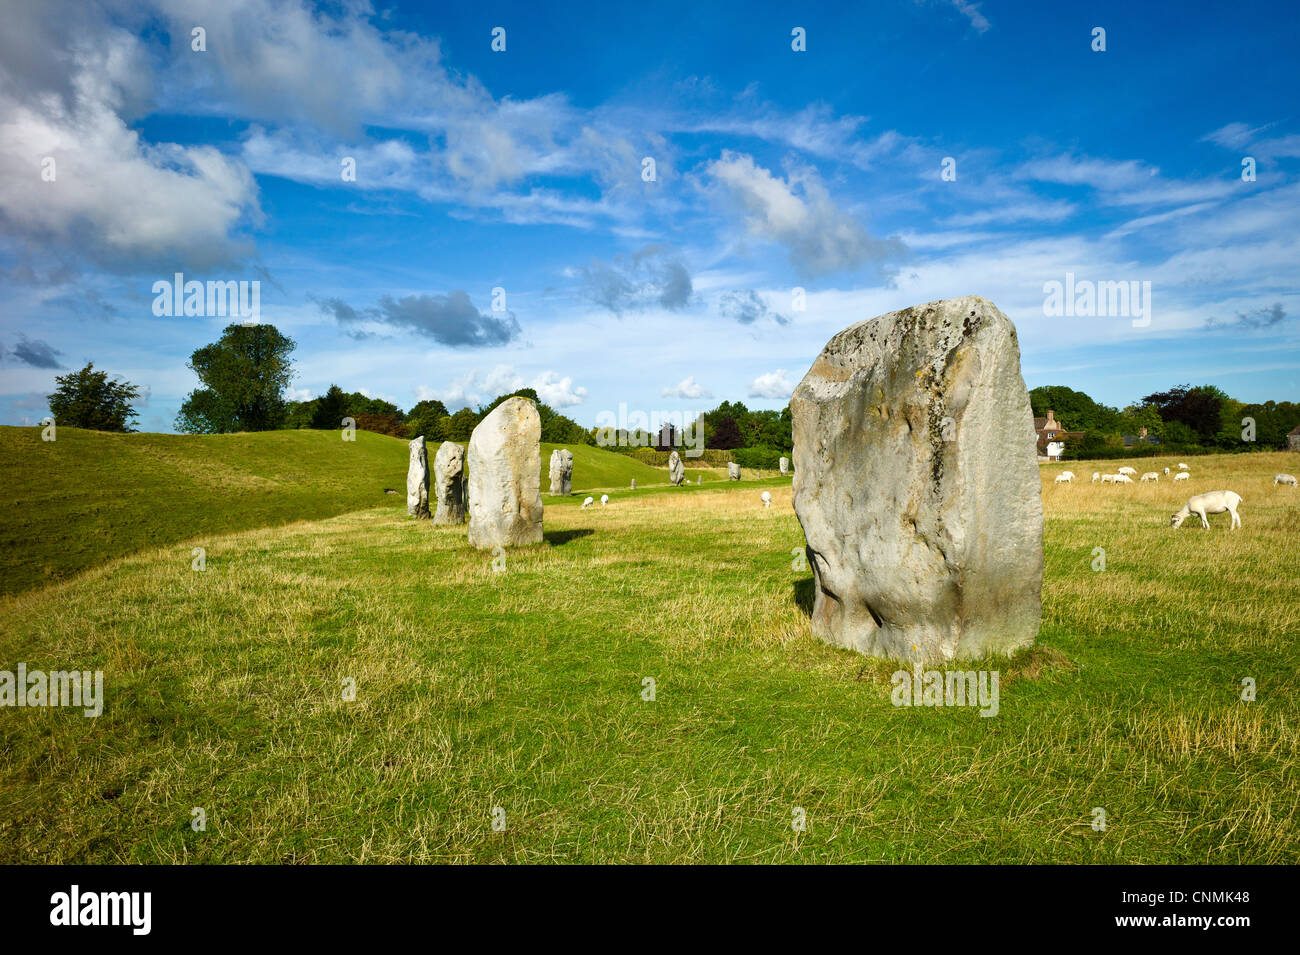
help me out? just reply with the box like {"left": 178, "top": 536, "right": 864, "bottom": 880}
{"left": 0, "top": 0, "right": 1300, "bottom": 430}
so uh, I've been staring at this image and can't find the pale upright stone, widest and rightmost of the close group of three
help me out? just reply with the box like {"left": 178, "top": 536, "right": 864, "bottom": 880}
{"left": 469, "top": 398, "right": 542, "bottom": 551}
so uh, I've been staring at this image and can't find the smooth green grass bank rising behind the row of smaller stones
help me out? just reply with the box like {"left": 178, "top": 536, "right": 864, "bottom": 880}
{"left": 0, "top": 426, "right": 691, "bottom": 594}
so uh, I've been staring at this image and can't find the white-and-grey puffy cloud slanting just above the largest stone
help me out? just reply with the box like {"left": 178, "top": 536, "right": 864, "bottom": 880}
{"left": 706, "top": 151, "right": 906, "bottom": 275}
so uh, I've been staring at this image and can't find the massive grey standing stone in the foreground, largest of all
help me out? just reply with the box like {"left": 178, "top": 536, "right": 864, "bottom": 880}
{"left": 790, "top": 296, "right": 1043, "bottom": 660}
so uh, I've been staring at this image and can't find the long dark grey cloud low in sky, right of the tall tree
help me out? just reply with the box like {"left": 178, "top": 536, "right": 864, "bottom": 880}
{"left": 317, "top": 290, "right": 520, "bottom": 348}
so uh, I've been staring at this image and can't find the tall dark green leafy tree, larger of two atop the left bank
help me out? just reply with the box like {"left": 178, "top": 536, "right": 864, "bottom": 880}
{"left": 176, "top": 325, "right": 294, "bottom": 434}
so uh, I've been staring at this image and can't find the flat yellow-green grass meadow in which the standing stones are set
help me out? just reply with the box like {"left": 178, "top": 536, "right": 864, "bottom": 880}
{"left": 0, "top": 453, "right": 1300, "bottom": 863}
